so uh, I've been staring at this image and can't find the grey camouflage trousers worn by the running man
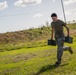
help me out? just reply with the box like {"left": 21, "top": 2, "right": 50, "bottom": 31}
{"left": 55, "top": 36, "right": 69, "bottom": 60}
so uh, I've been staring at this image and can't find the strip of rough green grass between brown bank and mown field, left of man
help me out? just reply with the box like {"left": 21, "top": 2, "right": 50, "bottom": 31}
{"left": 0, "top": 40, "right": 47, "bottom": 52}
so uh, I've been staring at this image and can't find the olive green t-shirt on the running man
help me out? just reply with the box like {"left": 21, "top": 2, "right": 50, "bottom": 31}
{"left": 51, "top": 20, "right": 66, "bottom": 35}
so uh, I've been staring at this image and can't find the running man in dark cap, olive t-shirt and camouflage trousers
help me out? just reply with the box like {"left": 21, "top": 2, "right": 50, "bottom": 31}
{"left": 51, "top": 13, "right": 73, "bottom": 67}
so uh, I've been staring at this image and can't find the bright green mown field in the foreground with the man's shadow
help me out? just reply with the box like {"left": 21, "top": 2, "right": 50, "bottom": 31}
{"left": 0, "top": 39, "right": 76, "bottom": 75}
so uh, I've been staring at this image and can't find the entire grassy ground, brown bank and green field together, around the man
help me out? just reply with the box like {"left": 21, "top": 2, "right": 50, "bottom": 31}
{"left": 0, "top": 25, "right": 76, "bottom": 75}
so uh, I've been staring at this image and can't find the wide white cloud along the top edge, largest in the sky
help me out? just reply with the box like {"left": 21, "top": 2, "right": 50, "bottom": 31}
{"left": 14, "top": 0, "right": 42, "bottom": 7}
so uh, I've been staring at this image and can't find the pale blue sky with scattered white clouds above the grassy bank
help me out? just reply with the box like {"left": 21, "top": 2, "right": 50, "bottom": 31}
{"left": 0, "top": 0, "right": 76, "bottom": 33}
